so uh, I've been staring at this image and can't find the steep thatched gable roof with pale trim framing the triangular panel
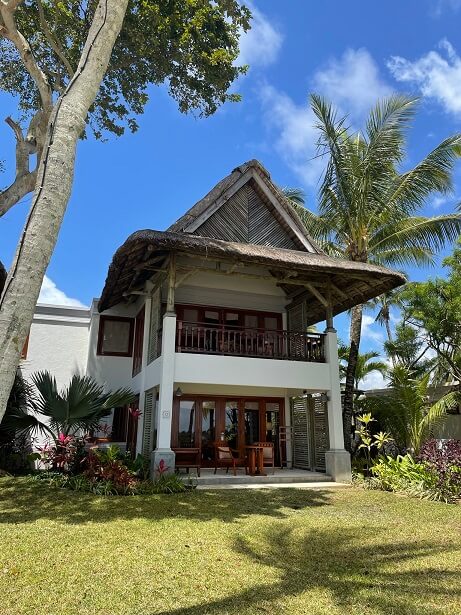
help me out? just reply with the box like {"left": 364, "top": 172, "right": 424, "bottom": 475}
{"left": 167, "top": 160, "right": 322, "bottom": 254}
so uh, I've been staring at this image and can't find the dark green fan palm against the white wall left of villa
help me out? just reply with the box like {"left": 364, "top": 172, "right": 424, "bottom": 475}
{"left": 8, "top": 371, "right": 136, "bottom": 440}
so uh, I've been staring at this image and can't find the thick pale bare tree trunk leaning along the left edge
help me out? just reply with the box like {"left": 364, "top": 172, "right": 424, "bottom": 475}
{"left": 0, "top": 0, "right": 128, "bottom": 421}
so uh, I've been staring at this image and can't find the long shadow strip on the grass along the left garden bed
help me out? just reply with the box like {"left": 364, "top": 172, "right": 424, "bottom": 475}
{"left": 0, "top": 478, "right": 329, "bottom": 524}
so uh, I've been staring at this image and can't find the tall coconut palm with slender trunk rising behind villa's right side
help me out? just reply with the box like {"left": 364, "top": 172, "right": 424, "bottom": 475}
{"left": 286, "top": 95, "right": 461, "bottom": 448}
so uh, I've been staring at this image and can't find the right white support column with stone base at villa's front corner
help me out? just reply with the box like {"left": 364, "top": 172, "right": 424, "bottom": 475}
{"left": 325, "top": 324, "right": 351, "bottom": 482}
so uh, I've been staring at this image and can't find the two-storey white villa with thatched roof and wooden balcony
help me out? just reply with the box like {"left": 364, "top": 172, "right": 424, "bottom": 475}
{"left": 23, "top": 160, "right": 404, "bottom": 481}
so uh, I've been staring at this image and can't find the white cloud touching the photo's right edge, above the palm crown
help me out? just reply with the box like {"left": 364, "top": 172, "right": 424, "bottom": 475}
{"left": 387, "top": 39, "right": 461, "bottom": 117}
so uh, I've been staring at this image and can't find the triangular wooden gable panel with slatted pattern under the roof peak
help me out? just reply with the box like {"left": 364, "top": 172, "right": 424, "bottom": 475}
{"left": 193, "top": 184, "right": 297, "bottom": 250}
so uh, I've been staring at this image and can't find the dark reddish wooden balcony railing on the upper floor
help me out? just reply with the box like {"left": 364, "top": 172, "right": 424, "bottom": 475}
{"left": 176, "top": 320, "right": 325, "bottom": 363}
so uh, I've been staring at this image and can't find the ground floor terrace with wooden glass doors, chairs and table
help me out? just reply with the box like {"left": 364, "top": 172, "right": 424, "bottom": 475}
{"left": 138, "top": 384, "right": 350, "bottom": 482}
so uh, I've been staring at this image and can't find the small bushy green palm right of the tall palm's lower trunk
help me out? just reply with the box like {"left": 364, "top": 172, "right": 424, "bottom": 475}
{"left": 367, "top": 365, "right": 460, "bottom": 455}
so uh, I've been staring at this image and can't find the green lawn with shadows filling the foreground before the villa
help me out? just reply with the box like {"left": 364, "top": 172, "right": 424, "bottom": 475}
{"left": 0, "top": 478, "right": 461, "bottom": 615}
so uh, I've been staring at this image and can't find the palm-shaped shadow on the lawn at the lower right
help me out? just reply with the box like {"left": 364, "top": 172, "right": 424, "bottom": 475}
{"left": 159, "top": 527, "right": 461, "bottom": 615}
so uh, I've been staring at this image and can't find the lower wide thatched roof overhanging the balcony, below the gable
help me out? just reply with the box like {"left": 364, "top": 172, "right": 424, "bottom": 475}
{"left": 99, "top": 230, "right": 405, "bottom": 324}
